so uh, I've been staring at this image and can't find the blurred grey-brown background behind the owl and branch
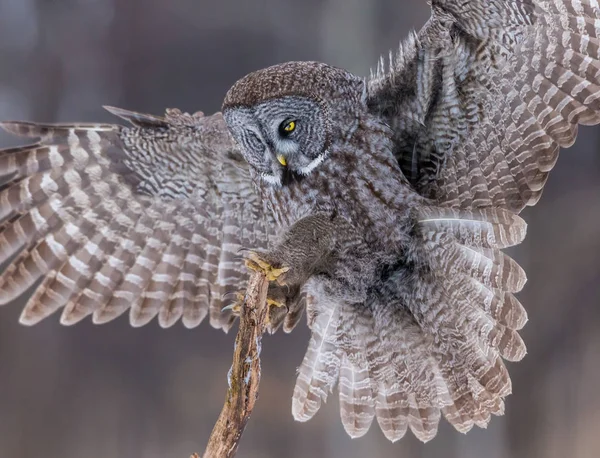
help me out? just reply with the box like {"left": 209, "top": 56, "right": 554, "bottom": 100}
{"left": 0, "top": 0, "right": 600, "bottom": 458}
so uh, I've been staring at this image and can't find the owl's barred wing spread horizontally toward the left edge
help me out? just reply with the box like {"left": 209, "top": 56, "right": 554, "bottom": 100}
{"left": 0, "top": 108, "right": 274, "bottom": 330}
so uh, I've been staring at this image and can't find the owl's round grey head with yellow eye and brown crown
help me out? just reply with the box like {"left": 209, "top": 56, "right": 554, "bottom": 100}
{"left": 223, "top": 62, "right": 366, "bottom": 186}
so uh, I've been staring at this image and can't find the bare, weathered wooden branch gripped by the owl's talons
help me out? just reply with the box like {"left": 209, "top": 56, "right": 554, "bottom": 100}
{"left": 198, "top": 272, "right": 269, "bottom": 458}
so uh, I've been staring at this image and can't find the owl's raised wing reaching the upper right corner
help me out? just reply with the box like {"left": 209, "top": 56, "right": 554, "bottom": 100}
{"left": 369, "top": 0, "right": 600, "bottom": 212}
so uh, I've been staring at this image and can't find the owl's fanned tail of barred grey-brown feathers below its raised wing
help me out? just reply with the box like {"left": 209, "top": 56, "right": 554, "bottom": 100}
{"left": 293, "top": 204, "right": 527, "bottom": 442}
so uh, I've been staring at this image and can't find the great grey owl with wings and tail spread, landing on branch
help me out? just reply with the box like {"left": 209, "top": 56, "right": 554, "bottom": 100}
{"left": 0, "top": 0, "right": 600, "bottom": 441}
